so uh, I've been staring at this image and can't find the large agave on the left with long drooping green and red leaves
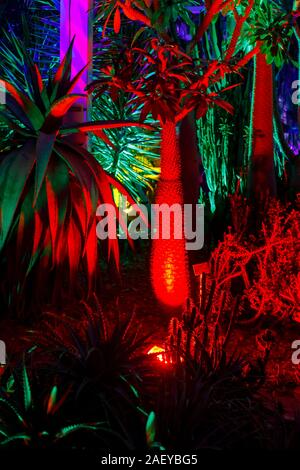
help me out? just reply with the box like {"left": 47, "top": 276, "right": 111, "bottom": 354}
{"left": 0, "top": 42, "right": 150, "bottom": 316}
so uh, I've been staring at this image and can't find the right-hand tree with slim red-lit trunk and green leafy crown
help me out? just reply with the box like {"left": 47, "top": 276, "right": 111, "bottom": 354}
{"left": 240, "top": 0, "right": 294, "bottom": 208}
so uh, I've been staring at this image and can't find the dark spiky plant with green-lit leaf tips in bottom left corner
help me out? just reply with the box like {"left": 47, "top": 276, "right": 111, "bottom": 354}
{"left": 0, "top": 365, "right": 106, "bottom": 448}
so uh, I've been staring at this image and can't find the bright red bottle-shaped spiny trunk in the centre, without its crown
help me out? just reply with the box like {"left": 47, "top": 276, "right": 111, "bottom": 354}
{"left": 151, "top": 122, "right": 189, "bottom": 307}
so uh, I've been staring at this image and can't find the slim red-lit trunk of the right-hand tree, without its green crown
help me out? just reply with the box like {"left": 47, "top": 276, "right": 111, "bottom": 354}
{"left": 250, "top": 52, "right": 276, "bottom": 208}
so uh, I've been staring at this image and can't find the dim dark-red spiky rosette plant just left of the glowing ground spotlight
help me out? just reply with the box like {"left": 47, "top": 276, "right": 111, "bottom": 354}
{"left": 30, "top": 301, "right": 149, "bottom": 403}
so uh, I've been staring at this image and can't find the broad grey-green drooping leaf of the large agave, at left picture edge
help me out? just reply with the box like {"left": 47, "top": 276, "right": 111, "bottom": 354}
{"left": 0, "top": 141, "right": 36, "bottom": 250}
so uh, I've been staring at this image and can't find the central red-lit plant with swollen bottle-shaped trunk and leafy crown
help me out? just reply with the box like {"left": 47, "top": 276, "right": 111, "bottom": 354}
{"left": 92, "top": 39, "right": 245, "bottom": 307}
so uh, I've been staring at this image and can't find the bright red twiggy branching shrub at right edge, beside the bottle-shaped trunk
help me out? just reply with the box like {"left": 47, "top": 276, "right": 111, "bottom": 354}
{"left": 210, "top": 202, "right": 300, "bottom": 321}
